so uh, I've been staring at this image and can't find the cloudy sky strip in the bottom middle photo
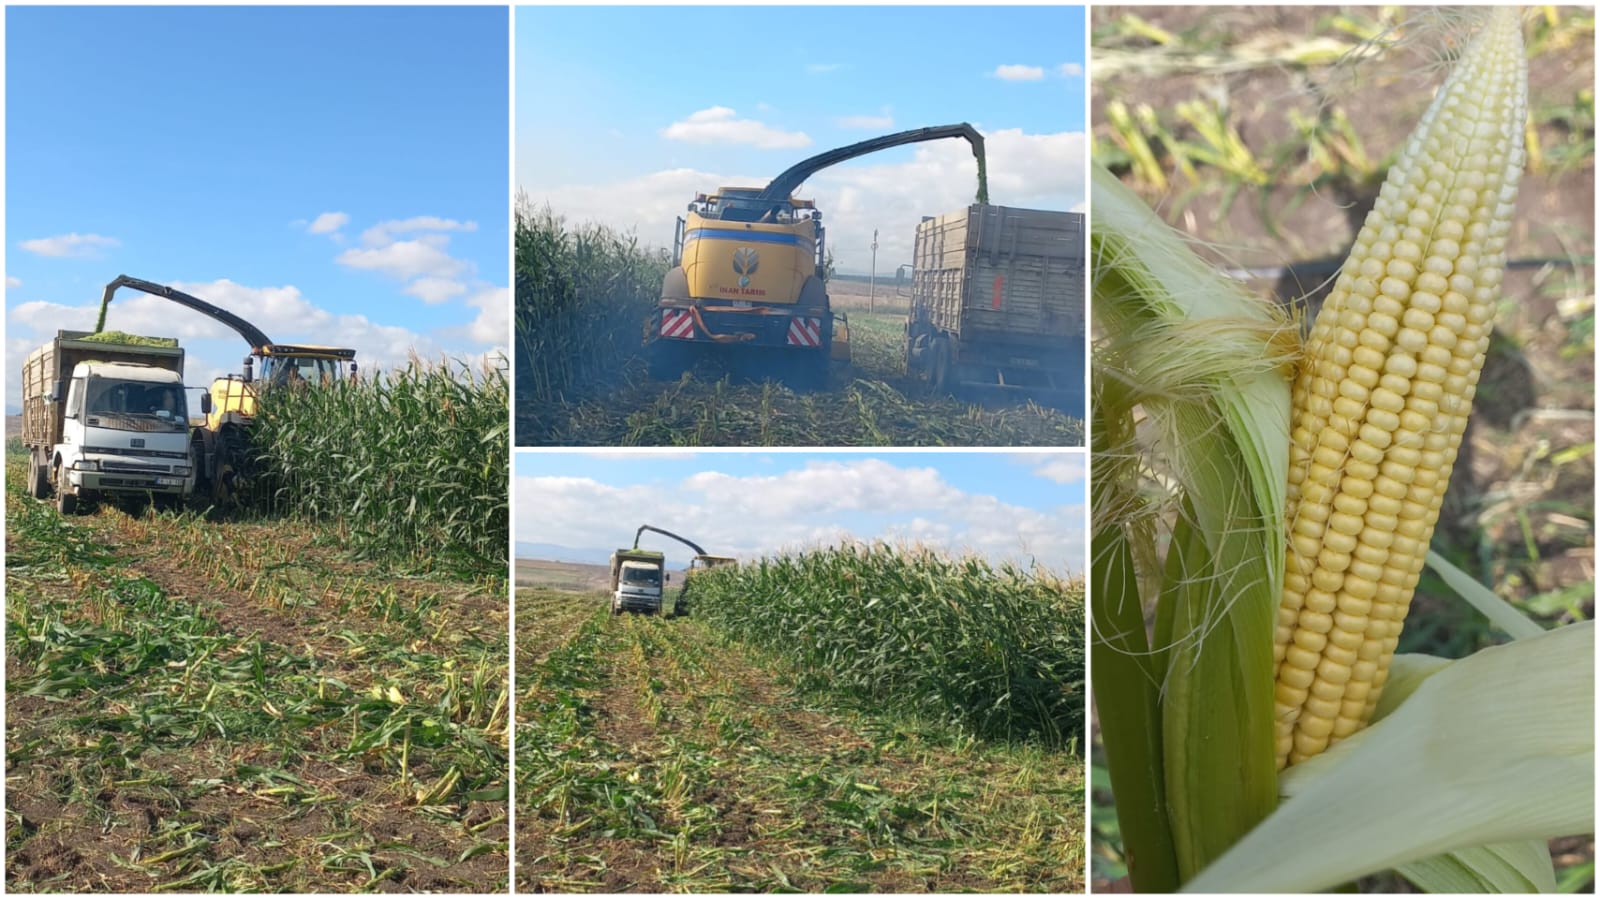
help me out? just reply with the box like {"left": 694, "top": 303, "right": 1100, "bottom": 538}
{"left": 514, "top": 453, "right": 1086, "bottom": 573}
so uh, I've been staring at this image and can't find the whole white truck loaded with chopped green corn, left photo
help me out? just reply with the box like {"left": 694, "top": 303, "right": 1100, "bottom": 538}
{"left": 22, "top": 331, "right": 194, "bottom": 515}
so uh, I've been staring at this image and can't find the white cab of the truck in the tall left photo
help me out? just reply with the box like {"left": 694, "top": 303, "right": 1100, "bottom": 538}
{"left": 48, "top": 362, "right": 194, "bottom": 512}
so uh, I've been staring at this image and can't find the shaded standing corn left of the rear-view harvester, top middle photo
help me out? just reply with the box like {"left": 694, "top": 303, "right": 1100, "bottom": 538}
{"left": 515, "top": 198, "right": 667, "bottom": 402}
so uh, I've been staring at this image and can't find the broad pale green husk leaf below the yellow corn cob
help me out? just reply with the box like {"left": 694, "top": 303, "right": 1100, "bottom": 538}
{"left": 1186, "top": 621, "right": 1595, "bottom": 893}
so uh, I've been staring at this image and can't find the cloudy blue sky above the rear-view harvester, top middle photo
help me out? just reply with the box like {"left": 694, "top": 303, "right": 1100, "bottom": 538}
{"left": 515, "top": 6, "right": 1086, "bottom": 272}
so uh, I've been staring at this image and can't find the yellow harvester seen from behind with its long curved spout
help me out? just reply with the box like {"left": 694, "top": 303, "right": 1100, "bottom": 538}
{"left": 645, "top": 123, "right": 989, "bottom": 387}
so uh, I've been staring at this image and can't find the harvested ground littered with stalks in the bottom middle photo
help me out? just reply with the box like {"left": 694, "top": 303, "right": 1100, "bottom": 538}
{"left": 517, "top": 590, "right": 1083, "bottom": 893}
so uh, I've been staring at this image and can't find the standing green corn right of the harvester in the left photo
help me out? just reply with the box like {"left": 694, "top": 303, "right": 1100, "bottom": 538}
{"left": 251, "top": 353, "right": 510, "bottom": 576}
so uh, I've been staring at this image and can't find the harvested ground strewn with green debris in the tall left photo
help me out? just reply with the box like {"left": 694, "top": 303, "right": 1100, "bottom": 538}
{"left": 6, "top": 486, "right": 509, "bottom": 893}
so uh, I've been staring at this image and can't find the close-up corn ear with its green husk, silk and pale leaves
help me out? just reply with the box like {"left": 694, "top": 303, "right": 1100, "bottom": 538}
{"left": 1091, "top": 8, "right": 1594, "bottom": 893}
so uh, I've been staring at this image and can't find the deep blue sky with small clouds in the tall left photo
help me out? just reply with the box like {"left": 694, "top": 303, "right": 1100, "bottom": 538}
{"left": 5, "top": 6, "right": 510, "bottom": 408}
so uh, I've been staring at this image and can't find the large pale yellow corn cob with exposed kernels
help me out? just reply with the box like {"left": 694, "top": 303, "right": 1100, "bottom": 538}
{"left": 1274, "top": 8, "right": 1528, "bottom": 768}
